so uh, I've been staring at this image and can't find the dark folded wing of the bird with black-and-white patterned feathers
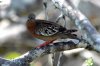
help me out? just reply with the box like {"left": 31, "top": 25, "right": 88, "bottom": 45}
{"left": 35, "top": 20, "right": 61, "bottom": 36}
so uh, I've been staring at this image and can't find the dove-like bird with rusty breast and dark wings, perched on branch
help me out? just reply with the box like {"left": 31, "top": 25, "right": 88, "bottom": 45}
{"left": 26, "top": 13, "right": 77, "bottom": 47}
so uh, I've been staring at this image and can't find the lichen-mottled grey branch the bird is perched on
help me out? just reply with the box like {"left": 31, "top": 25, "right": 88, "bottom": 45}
{"left": 0, "top": 40, "right": 91, "bottom": 66}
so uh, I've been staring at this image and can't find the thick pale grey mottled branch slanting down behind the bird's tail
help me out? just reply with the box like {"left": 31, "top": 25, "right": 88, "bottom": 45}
{"left": 52, "top": 0, "right": 100, "bottom": 52}
